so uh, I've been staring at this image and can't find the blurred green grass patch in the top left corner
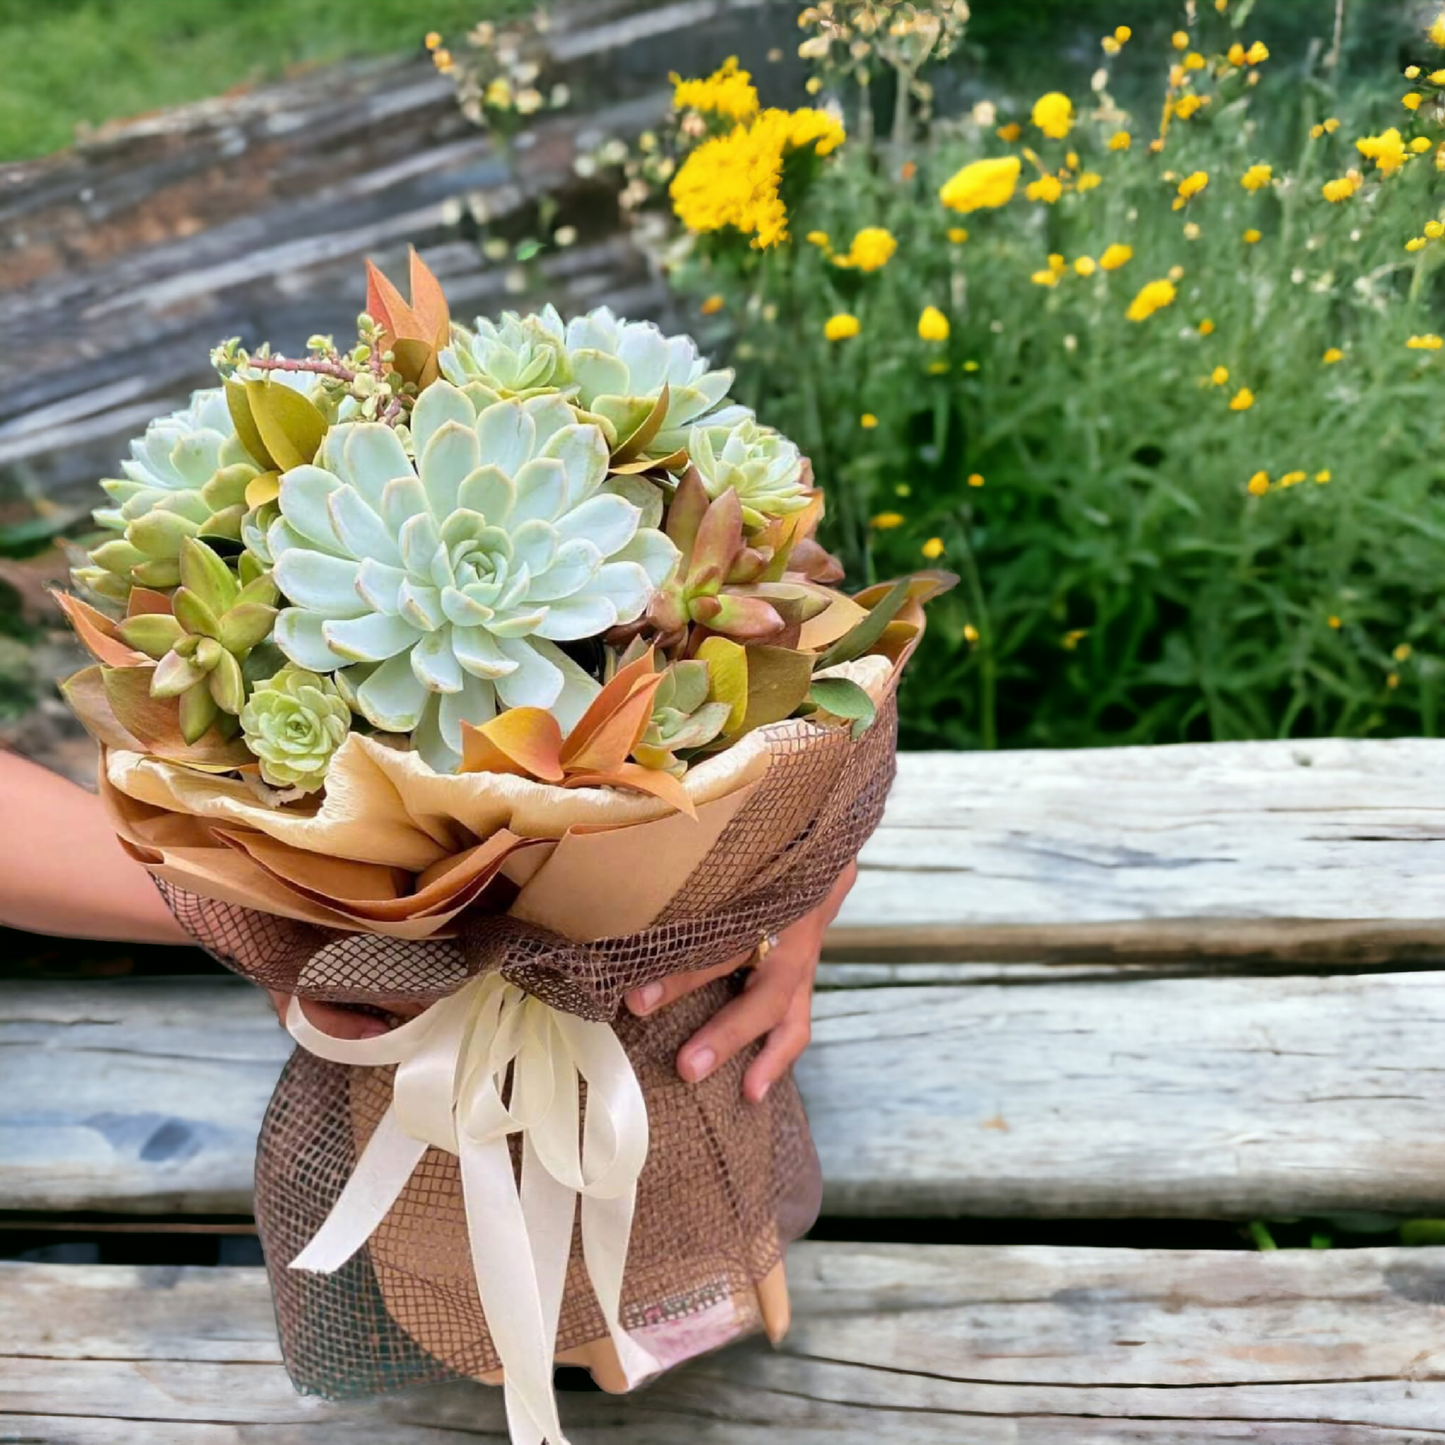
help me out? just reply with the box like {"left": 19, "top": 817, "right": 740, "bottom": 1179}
{"left": 0, "top": 0, "right": 529, "bottom": 162}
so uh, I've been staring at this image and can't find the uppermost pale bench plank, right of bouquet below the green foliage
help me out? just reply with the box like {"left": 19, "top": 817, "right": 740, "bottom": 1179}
{"left": 835, "top": 738, "right": 1445, "bottom": 959}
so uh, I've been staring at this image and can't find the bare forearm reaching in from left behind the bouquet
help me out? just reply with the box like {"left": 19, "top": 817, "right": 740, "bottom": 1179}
{"left": 0, "top": 751, "right": 189, "bottom": 944}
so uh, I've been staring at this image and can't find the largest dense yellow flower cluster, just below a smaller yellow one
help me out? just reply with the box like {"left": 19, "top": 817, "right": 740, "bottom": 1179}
{"left": 669, "top": 107, "right": 845, "bottom": 250}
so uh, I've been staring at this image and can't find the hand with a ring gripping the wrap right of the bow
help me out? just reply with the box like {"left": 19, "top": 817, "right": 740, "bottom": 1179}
{"left": 627, "top": 863, "right": 858, "bottom": 1104}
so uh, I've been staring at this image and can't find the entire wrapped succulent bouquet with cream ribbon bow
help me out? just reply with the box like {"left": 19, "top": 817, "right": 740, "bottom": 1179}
{"left": 62, "top": 254, "right": 952, "bottom": 1441}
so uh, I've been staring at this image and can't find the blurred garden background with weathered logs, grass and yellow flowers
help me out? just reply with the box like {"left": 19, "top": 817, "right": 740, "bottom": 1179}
{"left": 0, "top": 0, "right": 1445, "bottom": 766}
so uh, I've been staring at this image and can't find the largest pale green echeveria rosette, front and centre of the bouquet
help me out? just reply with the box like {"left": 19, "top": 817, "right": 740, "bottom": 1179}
{"left": 266, "top": 381, "right": 678, "bottom": 772}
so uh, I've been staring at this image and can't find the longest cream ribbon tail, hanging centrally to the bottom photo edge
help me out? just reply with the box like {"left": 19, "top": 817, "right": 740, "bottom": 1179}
{"left": 461, "top": 1136, "right": 571, "bottom": 1445}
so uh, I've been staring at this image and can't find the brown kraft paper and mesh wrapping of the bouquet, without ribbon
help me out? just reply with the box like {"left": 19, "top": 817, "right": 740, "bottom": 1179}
{"left": 101, "top": 642, "right": 912, "bottom": 1396}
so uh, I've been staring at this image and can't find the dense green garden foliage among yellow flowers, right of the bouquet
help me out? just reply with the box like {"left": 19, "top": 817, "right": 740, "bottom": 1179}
{"left": 661, "top": 11, "right": 1445, "bottom": 747}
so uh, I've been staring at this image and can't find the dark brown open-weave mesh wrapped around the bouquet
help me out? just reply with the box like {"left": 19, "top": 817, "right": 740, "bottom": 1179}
{"left": 162, "top": 698, "right": 897, "bottom": 1396}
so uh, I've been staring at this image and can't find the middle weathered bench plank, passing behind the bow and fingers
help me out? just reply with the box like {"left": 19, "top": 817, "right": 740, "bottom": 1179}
{"left": 8, "top": 972, "right": 1445, "bottom": 1218}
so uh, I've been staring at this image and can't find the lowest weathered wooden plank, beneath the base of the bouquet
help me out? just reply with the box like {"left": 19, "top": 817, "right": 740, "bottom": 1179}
{"left": 0, "top": 1244, "right": 1445, "bottom": 1445}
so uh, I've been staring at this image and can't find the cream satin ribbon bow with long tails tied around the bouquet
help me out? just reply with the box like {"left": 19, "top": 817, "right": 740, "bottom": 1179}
{"left": 286, "top": 974, "right": 660, "bottom": 1445}
